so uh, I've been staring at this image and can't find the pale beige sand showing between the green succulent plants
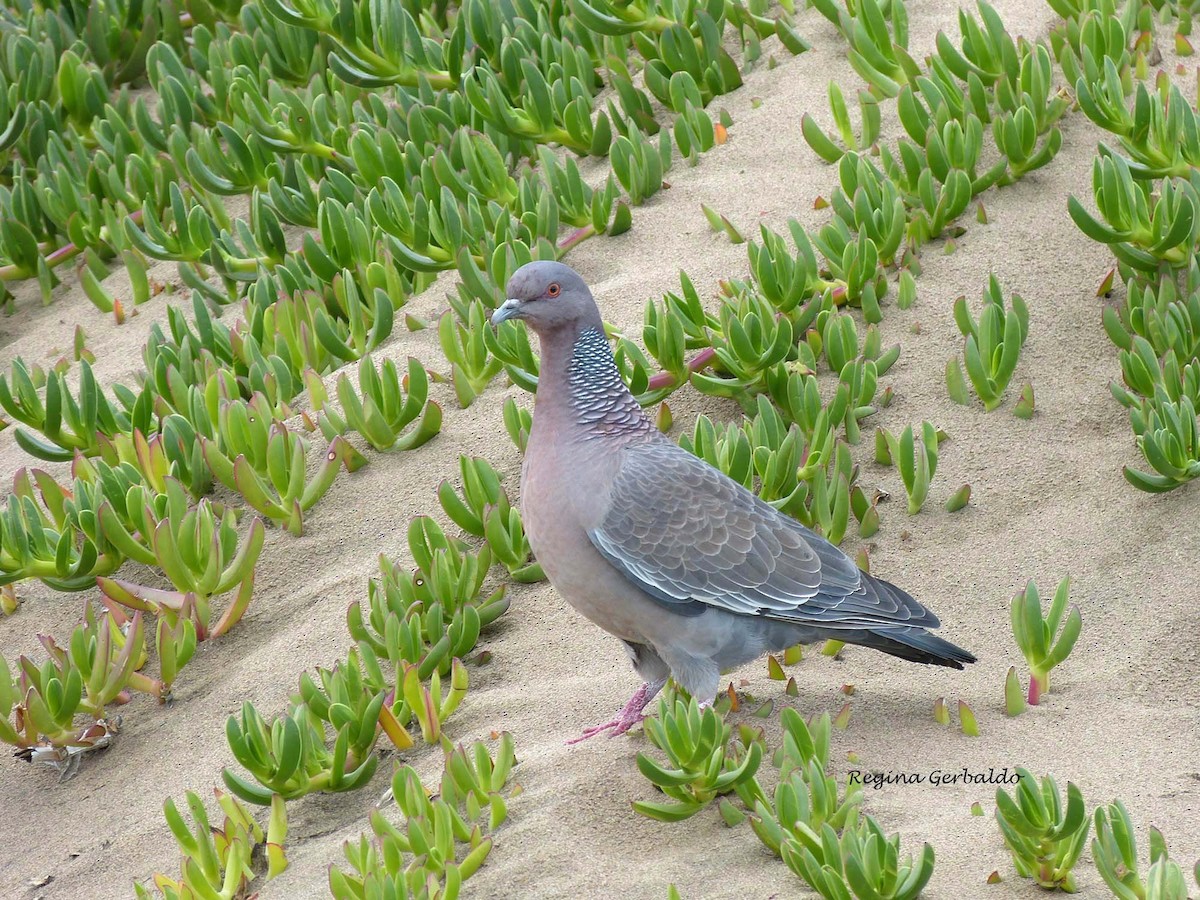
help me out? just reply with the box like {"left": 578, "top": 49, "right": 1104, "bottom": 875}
{"left": 0, "top": 0, "right": 1200, "bottom": 900}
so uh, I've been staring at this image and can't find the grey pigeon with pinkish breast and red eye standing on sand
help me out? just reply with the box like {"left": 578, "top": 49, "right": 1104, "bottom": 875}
{"left": 492, "top": 260, "right": 976, "bottom": 743}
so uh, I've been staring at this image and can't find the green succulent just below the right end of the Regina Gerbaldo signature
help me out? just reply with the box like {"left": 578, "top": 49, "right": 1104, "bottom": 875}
{"left": 996, "top": 767, "right": 1090, "bottom": 893}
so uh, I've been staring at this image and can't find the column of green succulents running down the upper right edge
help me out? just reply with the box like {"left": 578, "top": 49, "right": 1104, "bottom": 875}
{"left": 1068, "top": 4, "right": 1200, "bottom": 493}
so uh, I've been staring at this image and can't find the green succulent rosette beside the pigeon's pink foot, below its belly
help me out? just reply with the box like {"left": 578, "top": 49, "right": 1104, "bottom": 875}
{"left": 634, "top": 697, "right": 762, "bottom": 822}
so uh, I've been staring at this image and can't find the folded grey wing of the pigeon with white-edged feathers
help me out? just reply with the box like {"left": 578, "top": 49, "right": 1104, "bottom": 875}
{"left": 588, "top": 438, "right": 937, "bottom": 628}
